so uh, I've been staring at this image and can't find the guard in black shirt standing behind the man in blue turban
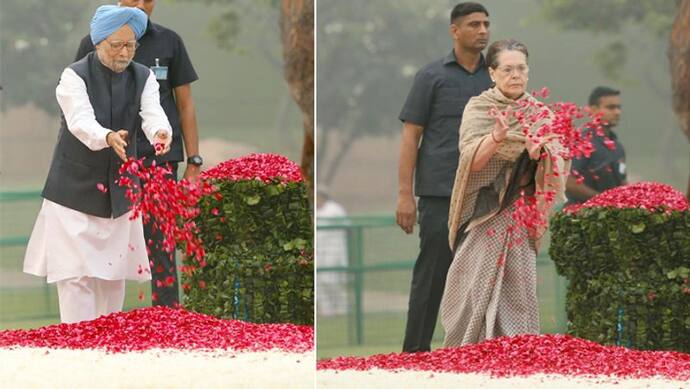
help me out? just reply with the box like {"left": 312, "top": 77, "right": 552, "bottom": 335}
{"left": 75, "top": 0, "right": 203, "bottom": 306}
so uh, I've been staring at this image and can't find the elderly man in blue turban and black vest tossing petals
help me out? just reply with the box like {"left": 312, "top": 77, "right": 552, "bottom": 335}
{"left": 24, "top": 5, "right": 172, "bottom": 323}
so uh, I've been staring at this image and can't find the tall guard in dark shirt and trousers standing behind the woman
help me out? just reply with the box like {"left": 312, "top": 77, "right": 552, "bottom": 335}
{"left": 396, "top": 2, "right": 491, "bottom": 352}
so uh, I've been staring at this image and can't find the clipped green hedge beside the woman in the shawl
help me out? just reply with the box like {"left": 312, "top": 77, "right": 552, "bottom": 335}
{"left": 549, "top": 208, "right": 690, "bottom": 352}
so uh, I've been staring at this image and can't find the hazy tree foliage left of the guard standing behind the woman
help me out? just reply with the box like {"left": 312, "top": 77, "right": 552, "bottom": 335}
{"left": 317, "top": 0, "right": 453, "bottom": 183}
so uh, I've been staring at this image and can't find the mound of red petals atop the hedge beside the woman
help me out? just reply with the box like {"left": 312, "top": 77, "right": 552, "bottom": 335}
{"left": 563, "top": 182, "right": 688, "bottom": 214}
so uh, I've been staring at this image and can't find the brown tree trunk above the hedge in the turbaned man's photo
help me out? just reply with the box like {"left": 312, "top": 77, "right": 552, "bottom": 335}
{"left": 280, "top": 0, "right": 314, "bottom": 196}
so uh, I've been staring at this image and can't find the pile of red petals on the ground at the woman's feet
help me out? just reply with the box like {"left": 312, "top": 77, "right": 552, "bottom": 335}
{"left": 317, "top": 335, "right": 690, "bottom": 380}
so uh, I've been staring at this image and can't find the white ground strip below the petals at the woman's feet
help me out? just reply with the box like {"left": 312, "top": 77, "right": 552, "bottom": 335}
{"left": 316, "top": 369, "right": 690, "bottom": 389}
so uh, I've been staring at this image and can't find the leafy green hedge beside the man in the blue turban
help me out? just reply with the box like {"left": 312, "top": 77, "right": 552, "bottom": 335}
{"left": 182, "top": 180, "right": 314, "bottom": 324}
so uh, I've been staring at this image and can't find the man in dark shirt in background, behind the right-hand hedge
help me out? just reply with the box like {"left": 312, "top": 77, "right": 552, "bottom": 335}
{"left": 566, "top": 86, "right": 627, "bottom": 204}
